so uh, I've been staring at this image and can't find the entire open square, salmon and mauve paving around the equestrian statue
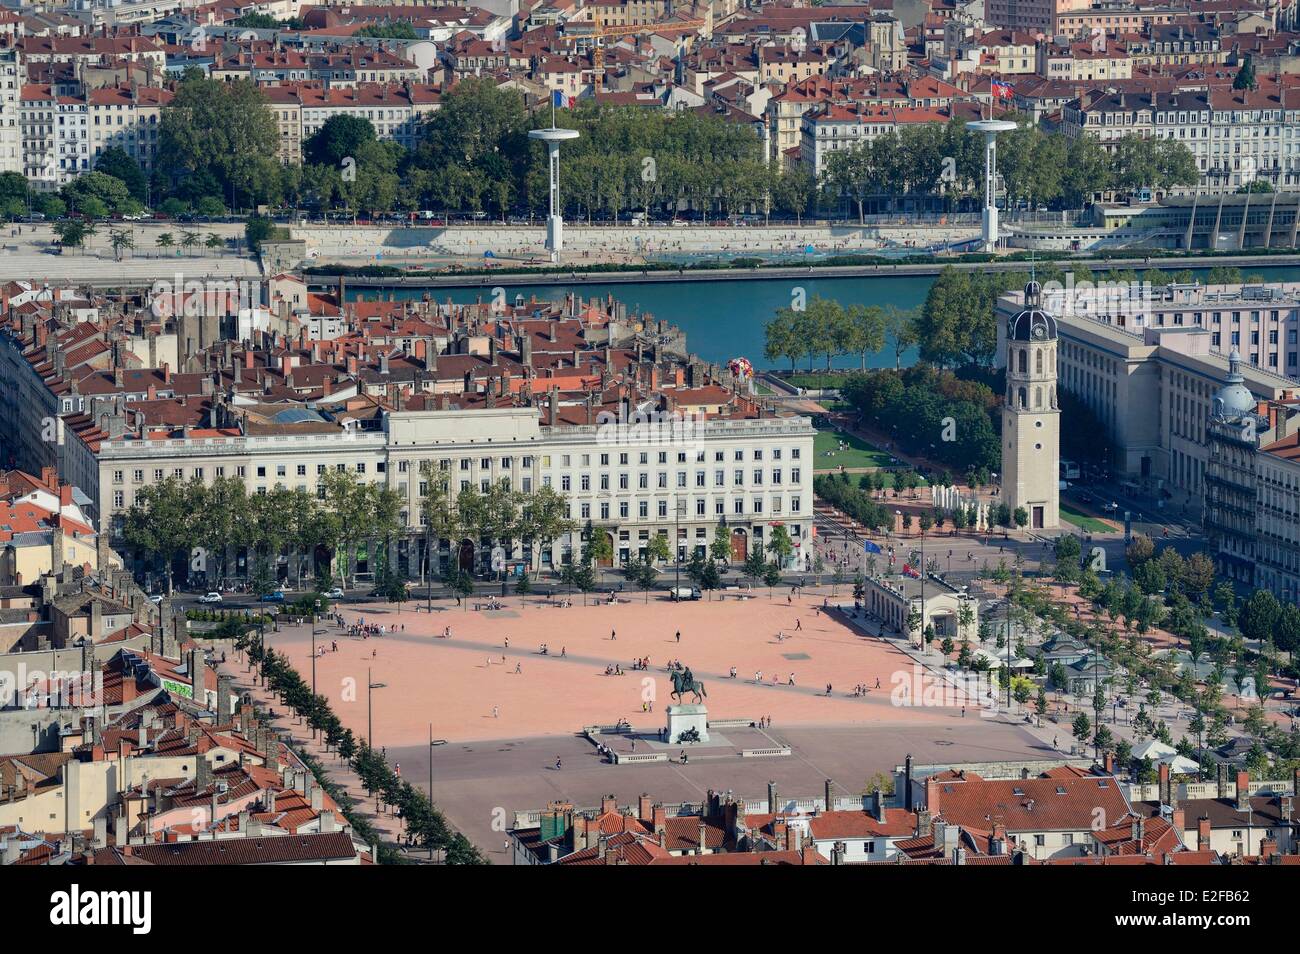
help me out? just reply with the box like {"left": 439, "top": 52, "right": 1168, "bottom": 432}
{"left": 270, "top": 591, "right": 1049, "bottom": 857}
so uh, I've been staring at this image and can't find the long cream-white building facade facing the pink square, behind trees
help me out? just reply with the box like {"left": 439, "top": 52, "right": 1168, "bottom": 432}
{"left": 94, "top": 407, "right": 814, "bottom": 576}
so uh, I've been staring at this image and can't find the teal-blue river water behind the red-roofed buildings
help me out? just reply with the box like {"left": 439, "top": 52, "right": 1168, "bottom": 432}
{"left": 348, "top": 263, "right": 1300, "bottom": 368}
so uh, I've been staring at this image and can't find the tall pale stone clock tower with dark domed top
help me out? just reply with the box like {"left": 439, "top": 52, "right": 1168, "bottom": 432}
{"left": 1002, "top": 281, "right": 1061, "bottom": 530}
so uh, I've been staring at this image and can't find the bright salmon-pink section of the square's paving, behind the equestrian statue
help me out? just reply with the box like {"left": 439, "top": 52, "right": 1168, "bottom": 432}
{"left": 272, "top": 590, "right": 982, "bottom": 746}
